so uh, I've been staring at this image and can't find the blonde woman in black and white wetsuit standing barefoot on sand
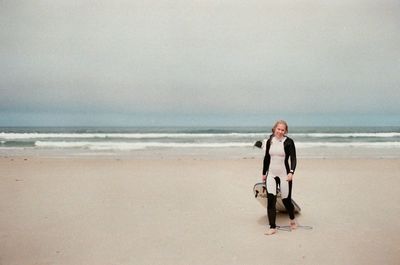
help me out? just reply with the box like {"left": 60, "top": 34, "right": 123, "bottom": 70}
{"left": 262, "top": 120, "right": 297, "bottom": 235}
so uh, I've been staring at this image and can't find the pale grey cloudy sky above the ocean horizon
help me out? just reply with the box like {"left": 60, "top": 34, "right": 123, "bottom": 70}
{"left": 0, "top": 0, "right": 400, "bottom": 126}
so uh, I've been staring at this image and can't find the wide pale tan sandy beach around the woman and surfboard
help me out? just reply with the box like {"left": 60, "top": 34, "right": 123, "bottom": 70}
{"left": 0, "top": 156, "right": 400, "bottom": 265}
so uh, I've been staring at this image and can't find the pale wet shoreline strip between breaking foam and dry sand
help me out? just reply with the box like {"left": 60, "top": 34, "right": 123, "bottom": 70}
{"left": 0, "top": 146, "right": 400, "bottom": 160}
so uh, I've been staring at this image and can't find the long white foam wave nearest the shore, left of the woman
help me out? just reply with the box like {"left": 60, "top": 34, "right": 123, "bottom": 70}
{"left": 35, "top": 141, "right": 252, "bottom": 150}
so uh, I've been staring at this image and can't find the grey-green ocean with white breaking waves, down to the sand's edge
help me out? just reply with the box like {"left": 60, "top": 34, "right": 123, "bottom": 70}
{"left": 0, "top": 126, "right": 400, "bottom": 158}
